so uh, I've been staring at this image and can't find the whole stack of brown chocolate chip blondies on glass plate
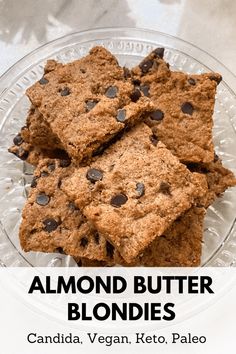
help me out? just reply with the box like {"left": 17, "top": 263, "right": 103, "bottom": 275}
{"left": 9, "top": 47, "right": 236, "bottom": 266}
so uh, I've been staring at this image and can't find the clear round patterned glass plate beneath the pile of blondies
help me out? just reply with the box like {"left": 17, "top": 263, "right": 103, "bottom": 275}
{"left": 0, "top": 28, "right": 236, "bottom": 266}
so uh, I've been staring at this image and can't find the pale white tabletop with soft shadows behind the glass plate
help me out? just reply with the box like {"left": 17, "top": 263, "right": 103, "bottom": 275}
{"left": 0, "top": 0, "right": 236, "bottom": 75}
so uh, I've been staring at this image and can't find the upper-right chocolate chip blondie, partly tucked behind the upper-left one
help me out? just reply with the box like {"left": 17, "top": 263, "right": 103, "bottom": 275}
{"left": 132, "top": 48, "right": 221, "bottom": 163}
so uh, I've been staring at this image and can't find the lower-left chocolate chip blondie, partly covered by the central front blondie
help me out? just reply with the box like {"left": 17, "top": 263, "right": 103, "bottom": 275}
{"left": 20, "top": 159, "right": 114, "bottom": 264}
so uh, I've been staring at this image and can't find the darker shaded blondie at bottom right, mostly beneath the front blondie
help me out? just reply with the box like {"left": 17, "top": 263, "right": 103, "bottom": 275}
{"left": 112, "top": 207, "right": 205, "bottom": 267}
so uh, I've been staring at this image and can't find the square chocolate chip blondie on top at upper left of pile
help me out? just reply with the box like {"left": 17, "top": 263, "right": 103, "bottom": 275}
{"left": 27, "top": 47, "right": 153, "bottom": 162}
